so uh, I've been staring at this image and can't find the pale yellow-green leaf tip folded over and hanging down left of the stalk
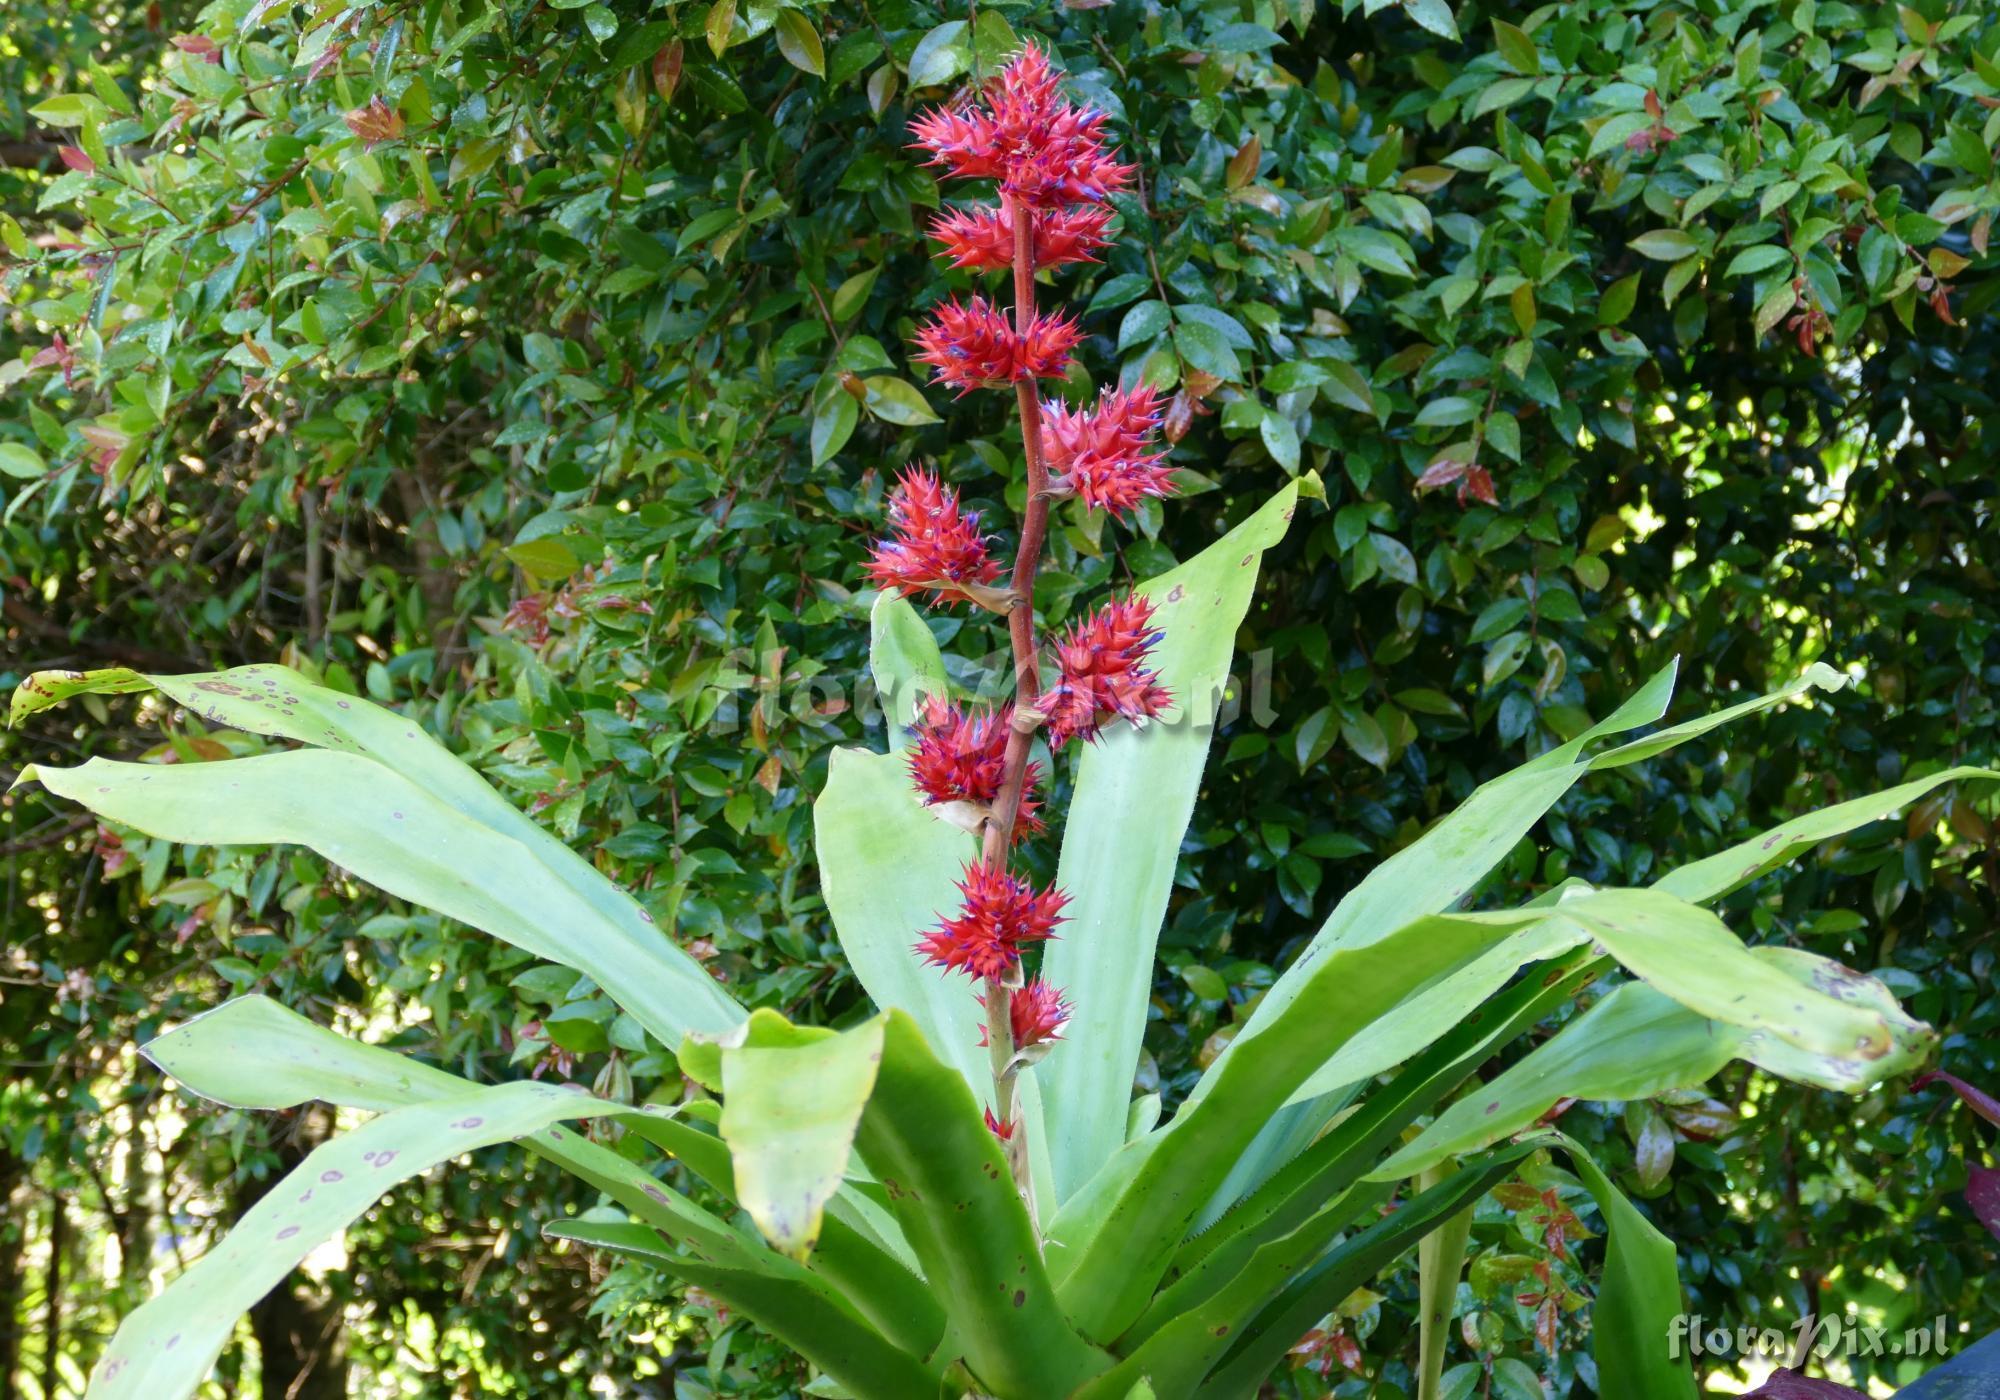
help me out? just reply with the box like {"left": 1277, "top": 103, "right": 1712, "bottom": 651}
{"left": 722, "top": 1010, "right": 882, "bottom": 1260}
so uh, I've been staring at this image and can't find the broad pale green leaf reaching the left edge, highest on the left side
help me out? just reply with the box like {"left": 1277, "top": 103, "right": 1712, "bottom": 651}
{"left": 14, "top": 666, "right": 744, "bottom": 1048}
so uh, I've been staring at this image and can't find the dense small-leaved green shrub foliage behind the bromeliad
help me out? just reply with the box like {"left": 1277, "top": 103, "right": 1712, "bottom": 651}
{"left": 0, "top": 0, "right": 2000, "bottom": 1394}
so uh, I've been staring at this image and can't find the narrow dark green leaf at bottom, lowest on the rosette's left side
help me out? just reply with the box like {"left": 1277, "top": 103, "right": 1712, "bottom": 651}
{"left": 542, "top": 1220, "right": 948, "bottom": 1400}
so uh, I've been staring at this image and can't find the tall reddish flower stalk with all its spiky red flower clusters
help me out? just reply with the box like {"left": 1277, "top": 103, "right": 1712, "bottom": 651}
{"left": 892, "top": 44, "right": 1170, "bottom": 1216}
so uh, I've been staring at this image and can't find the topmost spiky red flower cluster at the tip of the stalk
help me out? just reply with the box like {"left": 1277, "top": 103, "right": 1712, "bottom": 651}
{"left": 910, "top": 44, "right": 1138, "bottom": 208}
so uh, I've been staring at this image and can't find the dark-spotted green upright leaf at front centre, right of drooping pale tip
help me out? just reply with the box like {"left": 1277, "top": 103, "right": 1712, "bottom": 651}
{"left": 858, "top": 1010, "right": 1110, "bottom": 1400}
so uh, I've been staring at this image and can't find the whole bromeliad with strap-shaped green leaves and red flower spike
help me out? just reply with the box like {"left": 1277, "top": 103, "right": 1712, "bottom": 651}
{"left": 14, "top": 41, "right": 1994, "bottom": 1400}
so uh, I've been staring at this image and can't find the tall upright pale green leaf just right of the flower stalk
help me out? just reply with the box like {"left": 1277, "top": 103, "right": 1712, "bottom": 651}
{"left": 1040, "top": 486, "right": 1298, "bottom": 1200}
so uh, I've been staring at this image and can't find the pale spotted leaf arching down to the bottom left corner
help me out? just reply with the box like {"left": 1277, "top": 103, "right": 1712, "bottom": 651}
{"left": 88, "top": 1082, "right": 648, "bottom": 1400}
